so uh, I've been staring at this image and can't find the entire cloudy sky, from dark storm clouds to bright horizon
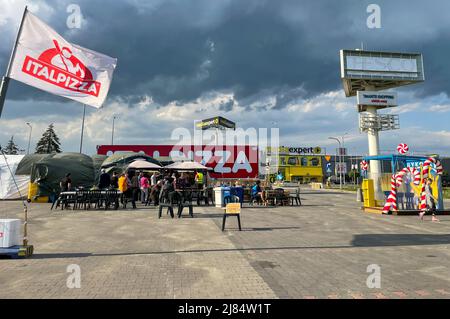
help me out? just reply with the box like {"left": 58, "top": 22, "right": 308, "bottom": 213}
{"left": 0, "top": 0, "right": 450, "bottom": 155}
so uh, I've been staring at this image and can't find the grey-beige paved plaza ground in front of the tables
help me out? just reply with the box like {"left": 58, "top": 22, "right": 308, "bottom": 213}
{"left": 0, "top": 190, "right": 450, "bottom": 299}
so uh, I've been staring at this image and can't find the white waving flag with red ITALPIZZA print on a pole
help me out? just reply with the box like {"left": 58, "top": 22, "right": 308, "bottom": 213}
{"left": 9, "top": 12, "right": 117, "bottom": 108}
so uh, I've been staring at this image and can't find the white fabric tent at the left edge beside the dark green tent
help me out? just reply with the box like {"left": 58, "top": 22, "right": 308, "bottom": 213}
{"left": 0, "top": 155, "right": 30, "bottom": 200}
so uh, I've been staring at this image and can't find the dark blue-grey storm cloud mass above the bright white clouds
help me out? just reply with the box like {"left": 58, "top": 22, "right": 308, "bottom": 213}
{"left": 0, "top": 0, "right": 450, "bottom": 107}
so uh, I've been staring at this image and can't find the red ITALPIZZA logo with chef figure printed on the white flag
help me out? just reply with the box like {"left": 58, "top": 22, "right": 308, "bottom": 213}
{"left": 22, "top": 40, "right": 101, "bottom": 97}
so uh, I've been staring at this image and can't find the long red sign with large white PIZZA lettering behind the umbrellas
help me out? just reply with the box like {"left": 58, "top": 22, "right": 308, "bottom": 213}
{"left": 97, "top": 145, "right": 258, "bottom": 178}
